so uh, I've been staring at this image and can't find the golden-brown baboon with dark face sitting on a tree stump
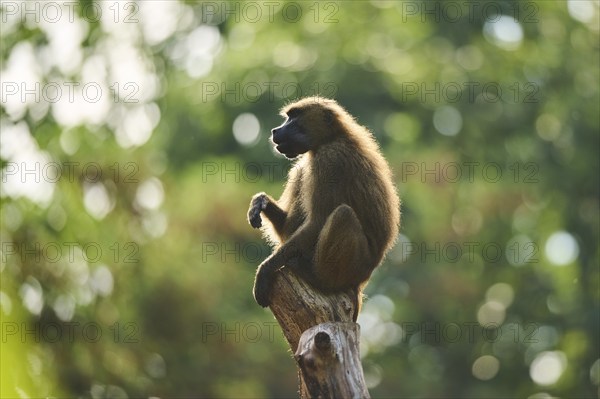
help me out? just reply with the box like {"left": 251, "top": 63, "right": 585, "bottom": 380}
{"left": 248, "top": 97, "right": 400, "bottom": 319}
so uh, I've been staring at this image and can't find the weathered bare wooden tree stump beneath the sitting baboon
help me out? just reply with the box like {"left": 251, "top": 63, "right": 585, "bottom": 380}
{"left": 270, "top": 267, "right": 369, "bottom": 398}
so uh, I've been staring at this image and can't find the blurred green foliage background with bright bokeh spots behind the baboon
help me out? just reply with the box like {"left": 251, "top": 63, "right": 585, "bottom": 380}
{"left": 0, "top": 0, "right": 600, "bottom": 398}
